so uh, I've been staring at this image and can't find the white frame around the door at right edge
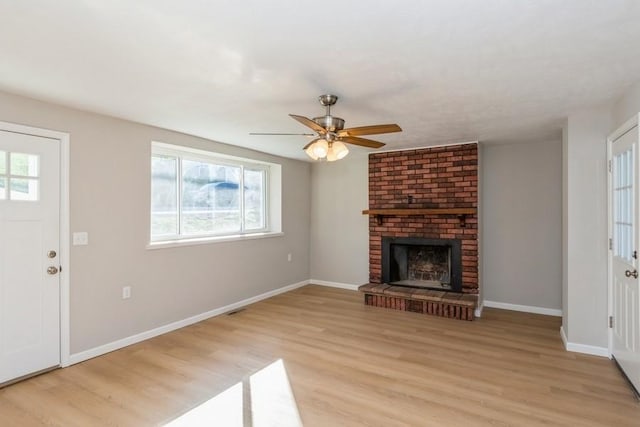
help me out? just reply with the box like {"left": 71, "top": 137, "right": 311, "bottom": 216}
{"left": 607, "top": 113, "right": 640, "bottom": 359}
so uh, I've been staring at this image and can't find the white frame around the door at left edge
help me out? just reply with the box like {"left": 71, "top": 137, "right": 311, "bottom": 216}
{"left": 0, "top": 121, "right": 71, "bottom": 368}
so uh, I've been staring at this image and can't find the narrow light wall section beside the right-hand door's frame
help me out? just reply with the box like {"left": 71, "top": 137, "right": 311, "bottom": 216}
{"left": 563, "top": 106, "right": 612, "bottom": 348}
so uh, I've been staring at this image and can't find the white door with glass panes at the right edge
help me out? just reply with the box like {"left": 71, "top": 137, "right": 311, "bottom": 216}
{"left": 610, "top": 124, "right": 640, "bottom": 390}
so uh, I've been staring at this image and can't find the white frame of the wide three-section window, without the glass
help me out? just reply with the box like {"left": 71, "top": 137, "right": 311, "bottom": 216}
{"left": 148, "top": 141, "right": 274, "bottom": 248}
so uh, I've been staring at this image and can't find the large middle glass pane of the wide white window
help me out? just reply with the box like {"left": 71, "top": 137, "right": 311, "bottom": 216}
{"left": 182, "top": 160, "right": 241, "bottom": 234}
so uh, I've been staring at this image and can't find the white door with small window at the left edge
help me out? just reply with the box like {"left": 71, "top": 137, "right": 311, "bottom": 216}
{"left": 0, "top": 131, "right": 60, "bottom": 384}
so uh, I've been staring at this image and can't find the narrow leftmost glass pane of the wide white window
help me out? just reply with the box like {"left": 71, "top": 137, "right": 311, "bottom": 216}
{"left": 151, "top": 156, "right": 178, "bottom": 237}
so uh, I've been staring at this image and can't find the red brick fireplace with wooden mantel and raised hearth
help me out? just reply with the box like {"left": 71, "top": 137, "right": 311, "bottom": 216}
{"left": 361, "top": 143, "right": 479, "bottom": 315}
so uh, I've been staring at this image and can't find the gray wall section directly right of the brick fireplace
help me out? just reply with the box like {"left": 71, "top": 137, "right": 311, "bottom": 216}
{"left": 481, "top": 141, "right": 562, "bottom": 310}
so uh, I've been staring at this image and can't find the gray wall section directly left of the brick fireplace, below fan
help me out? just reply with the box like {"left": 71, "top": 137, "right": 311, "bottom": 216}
{"left": 311, "top": 152, "right": 369, "bottom": 285}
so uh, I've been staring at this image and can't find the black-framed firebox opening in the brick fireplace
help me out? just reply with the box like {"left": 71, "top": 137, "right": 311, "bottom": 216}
{"left": 382, "top": 237, "right": 462, "bottom": 292}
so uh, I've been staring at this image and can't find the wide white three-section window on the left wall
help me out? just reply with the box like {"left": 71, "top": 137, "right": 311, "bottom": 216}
{"left": 151, "top": 142, "right": 279, "bottom": 243}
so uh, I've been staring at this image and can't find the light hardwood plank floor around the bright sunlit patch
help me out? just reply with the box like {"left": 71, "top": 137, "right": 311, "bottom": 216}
{"left": 0, "top": 285, "right": 640, "bottom": 426}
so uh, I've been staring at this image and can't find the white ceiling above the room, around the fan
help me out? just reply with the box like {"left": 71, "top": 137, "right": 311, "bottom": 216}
{"left": 0, "top": 0, "right": 640, "bottom": 159}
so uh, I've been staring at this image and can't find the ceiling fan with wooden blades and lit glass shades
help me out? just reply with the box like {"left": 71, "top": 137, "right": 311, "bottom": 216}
{"left": 250, "top": 94, "right": 402, "bottom": 162}
